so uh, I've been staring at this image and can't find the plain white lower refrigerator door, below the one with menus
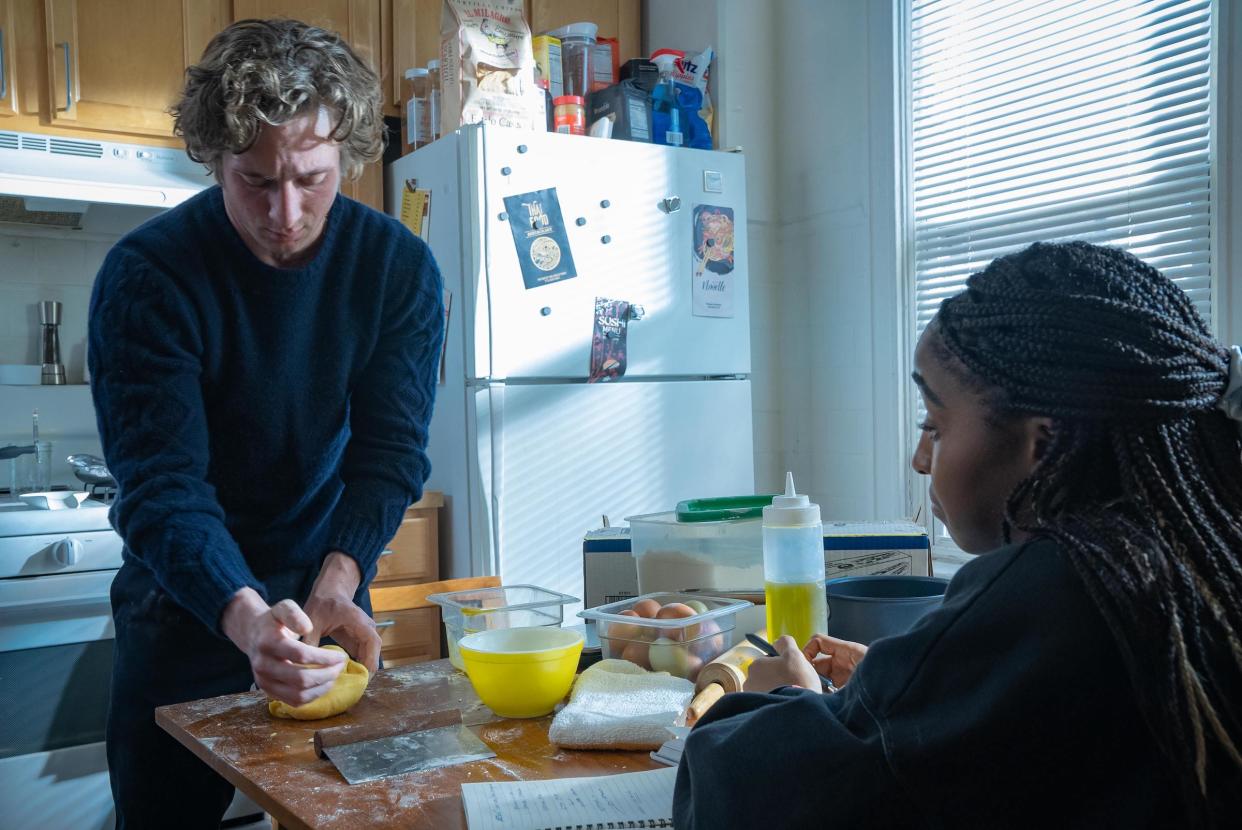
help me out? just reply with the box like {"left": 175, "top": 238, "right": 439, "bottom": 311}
{"left": 481, "top": 380, "right": 754, "bottom": 614}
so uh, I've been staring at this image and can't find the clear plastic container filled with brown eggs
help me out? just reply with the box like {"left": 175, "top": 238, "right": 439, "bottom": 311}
{"left": 578, "top": 593, "right": 751, "bottom": 681}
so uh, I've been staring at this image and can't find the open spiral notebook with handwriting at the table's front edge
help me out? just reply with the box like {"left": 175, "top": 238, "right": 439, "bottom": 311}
{"left": 462, "top": 768, "right": 677, "bottom": 830}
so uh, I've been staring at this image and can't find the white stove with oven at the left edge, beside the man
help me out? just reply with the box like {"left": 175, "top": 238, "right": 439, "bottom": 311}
{"left": 0, "top": 496, "right": 261, "bottom": 830}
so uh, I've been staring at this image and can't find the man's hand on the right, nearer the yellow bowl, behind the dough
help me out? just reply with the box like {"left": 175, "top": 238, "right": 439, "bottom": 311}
{"left": 302, "top": 552, "right": 380, "bottom": 675}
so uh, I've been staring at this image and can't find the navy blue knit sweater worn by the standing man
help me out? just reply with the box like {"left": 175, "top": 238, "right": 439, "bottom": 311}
{"left": 89, "top": 188, "right": 443, "bottom": 632}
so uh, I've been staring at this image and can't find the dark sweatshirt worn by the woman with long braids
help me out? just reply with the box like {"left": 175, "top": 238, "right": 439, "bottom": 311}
{"left": 674, "top": 540, "right": 1242, "bottom": 830}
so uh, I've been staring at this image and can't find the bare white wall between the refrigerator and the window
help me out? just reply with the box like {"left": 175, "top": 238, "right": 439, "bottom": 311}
{"left": 645, "top": 0, "right": 905, "bottom": 518}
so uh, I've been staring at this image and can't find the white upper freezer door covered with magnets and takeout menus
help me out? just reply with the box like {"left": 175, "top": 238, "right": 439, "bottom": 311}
{"left": 476, "top": 127, "right": 750, "bottom": 379}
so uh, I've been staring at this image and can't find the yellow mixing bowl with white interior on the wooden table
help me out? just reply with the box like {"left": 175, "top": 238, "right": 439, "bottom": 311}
{"left": 457, "top": 626, "right": 582, "bottom": 718}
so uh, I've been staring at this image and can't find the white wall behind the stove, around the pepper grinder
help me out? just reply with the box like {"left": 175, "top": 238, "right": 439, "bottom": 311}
{"left": 0, "top": 231, "right": 116, "bottom": 486}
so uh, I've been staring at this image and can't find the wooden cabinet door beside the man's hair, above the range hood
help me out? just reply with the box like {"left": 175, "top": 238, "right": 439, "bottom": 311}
{"left": 43, "top": 0, "right": 226, "bottom": 135}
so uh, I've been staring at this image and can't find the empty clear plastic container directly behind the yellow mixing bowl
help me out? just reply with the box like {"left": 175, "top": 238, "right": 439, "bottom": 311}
{"left": 427, "top": 585, "right": 578, "bottom": 671}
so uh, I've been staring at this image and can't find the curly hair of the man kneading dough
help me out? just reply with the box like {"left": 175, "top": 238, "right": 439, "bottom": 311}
{"left": 171, "top": 20, "right": 384, "bottom": 179}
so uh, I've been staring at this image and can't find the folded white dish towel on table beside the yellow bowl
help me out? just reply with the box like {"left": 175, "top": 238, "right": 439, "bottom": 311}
{"left": 548, "top": 660, "right": 694, "bottom": 749}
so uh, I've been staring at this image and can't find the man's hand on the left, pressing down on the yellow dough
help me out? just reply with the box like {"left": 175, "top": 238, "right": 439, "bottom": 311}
{"left": 221, "top": 588, "right": 345, "bottom": 706}
